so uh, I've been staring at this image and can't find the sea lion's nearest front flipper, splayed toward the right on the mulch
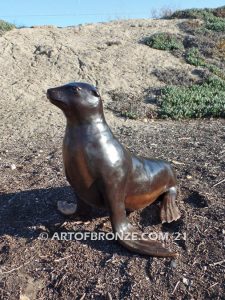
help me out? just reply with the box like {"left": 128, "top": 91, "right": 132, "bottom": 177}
{"left": 105, "top": 188, "right": 178, "bottom": 257}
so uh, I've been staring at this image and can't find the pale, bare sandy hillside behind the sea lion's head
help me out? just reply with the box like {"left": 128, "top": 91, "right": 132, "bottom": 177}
{"left": 0, "top": 20, "right": 198, "bottom": 147}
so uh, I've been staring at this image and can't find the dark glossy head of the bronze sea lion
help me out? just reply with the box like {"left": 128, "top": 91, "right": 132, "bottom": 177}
{"left": 47, "top": 82, "right": 103, "bottom": 120}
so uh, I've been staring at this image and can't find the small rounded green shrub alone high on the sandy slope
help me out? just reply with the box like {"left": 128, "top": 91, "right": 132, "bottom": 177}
{"left": 144, "top": 32, "right": 183, "bottom": 50}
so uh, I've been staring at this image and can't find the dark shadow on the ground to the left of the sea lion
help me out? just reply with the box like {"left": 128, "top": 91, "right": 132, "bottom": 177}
{"left": 0, "top": 186, "right": 105, "bottom": 239}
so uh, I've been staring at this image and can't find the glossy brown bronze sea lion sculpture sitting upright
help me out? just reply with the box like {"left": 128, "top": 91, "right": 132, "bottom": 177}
{"left": 47, "top": 82, "right": 180, "bottom": 257}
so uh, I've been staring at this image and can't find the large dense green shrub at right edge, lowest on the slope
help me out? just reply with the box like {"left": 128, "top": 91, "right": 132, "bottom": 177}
{"left": 159, "top": 77, "right": 225, "bottom": 119}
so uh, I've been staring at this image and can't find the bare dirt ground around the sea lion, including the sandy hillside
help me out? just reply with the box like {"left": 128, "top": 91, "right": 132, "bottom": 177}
{"left": 0, "top": 20, "right": 225, "bottom": 300}
